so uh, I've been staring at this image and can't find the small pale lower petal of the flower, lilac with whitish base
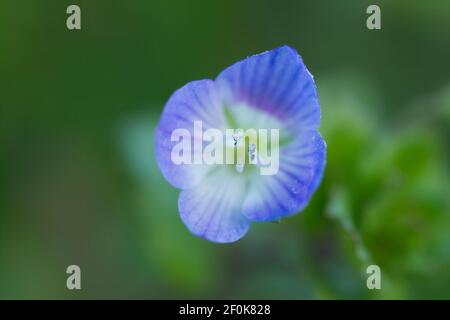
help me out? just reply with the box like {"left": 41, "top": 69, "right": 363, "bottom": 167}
{"left": 178, "top": 167, "right": 250, "bottom": 243}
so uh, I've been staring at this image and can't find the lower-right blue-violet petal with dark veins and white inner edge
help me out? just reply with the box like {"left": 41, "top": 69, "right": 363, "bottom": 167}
{"left": 242, "top": 131, "right": 326, "bottom": 221}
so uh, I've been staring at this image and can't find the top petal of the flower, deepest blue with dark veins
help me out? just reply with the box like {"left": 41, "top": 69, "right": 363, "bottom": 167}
{"left": 216, "top": 46, "right": 320, "bottom": 133}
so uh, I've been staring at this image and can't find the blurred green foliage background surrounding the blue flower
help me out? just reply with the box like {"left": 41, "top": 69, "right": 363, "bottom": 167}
{"left": 0, "top": 0, "right": 450, "bottom": 299}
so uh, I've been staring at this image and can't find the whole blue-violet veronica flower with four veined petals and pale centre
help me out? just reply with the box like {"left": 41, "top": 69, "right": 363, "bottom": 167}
{"left": 155, "top": 46, "right": 326, "bottom": 242}
